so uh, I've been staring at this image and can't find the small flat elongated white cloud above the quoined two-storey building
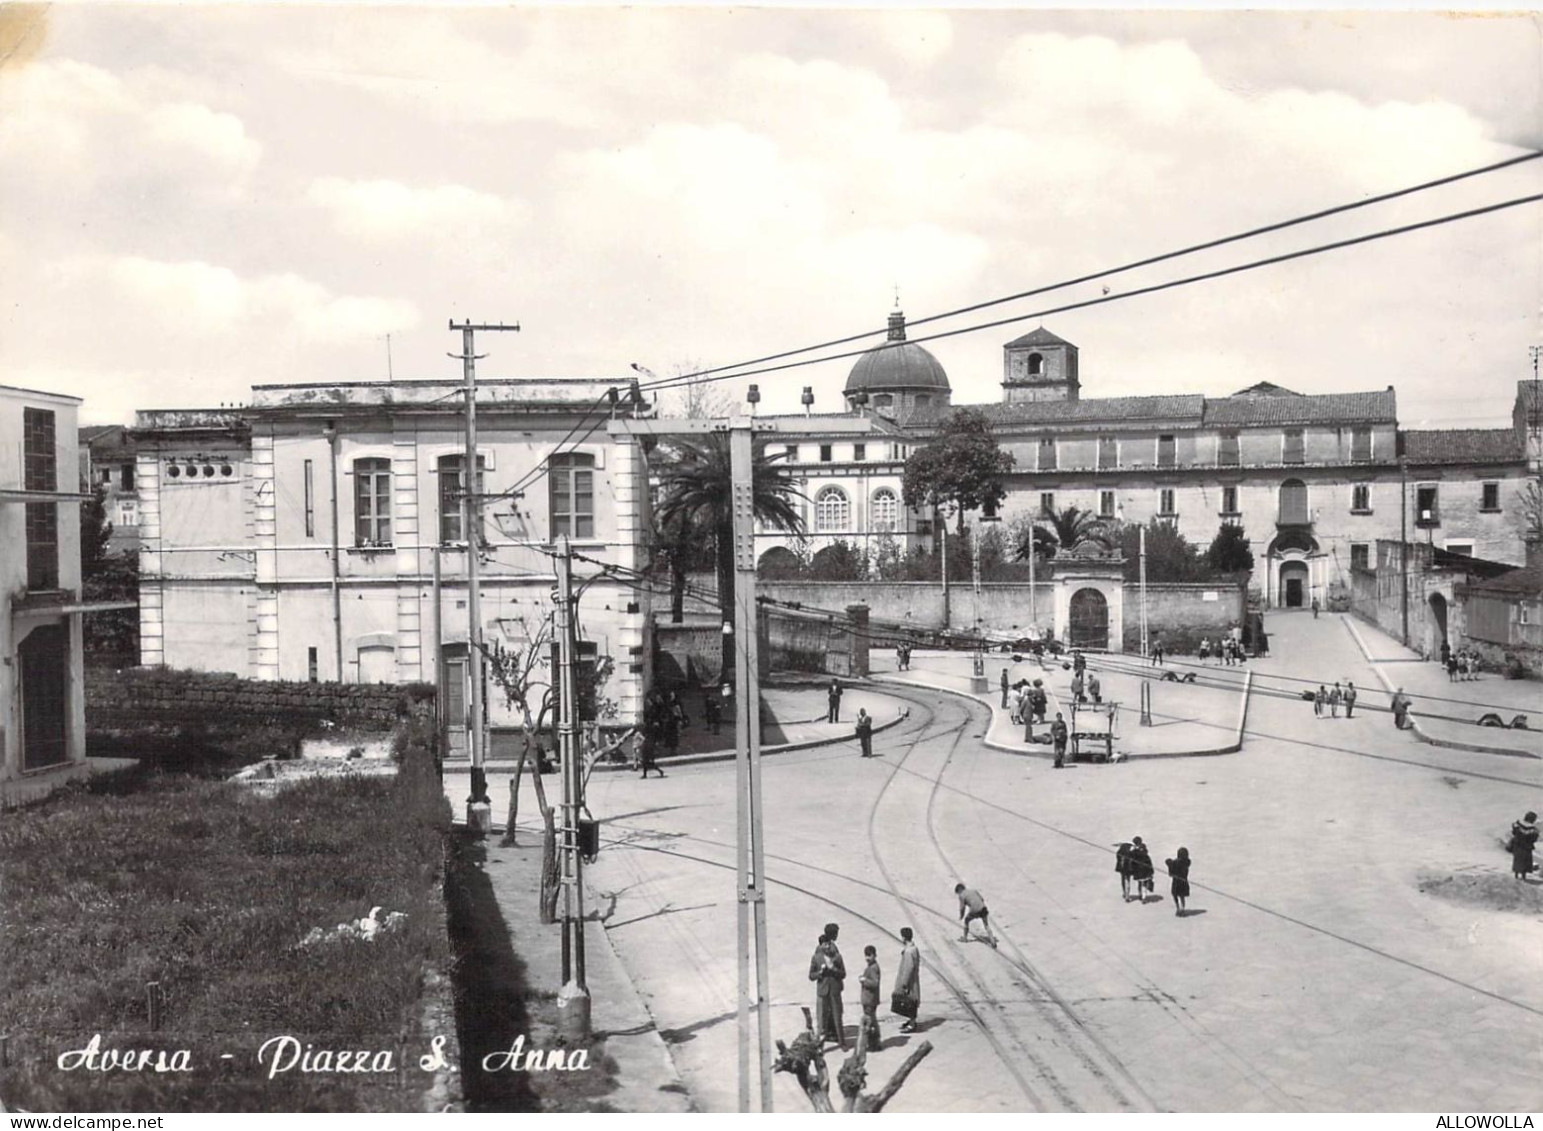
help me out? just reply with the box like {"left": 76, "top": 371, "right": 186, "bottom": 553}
{"left": 307, "top": 176, "right": 529, "bottom": 241}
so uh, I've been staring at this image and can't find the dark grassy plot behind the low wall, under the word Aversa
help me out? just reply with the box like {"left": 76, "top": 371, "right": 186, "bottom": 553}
{"left": 0, "top": 722, "right": 449, "bottom": 1111}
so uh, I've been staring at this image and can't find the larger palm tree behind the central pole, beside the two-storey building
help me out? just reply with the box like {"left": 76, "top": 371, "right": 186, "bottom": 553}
{"left": 654, "top": 432, "right": 804, "bottom": 635}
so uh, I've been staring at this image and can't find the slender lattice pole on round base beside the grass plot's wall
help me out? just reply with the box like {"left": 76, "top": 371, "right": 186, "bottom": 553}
{"left": 552, "top": 535, "right": 589, "bottom": 1046}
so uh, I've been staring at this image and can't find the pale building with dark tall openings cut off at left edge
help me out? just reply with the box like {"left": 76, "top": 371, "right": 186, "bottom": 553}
{"left": 0, "top": 386, "right": 88, "bottom": 805}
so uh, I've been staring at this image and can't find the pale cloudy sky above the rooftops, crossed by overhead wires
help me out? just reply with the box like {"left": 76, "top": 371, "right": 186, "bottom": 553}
{"left": 0, "top": 3, "right": 1543, "bottom": 427}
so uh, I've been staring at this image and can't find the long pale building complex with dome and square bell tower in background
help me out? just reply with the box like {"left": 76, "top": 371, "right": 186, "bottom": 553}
{"left": 761, "top": 312, "right": 1535, "bottom": 606}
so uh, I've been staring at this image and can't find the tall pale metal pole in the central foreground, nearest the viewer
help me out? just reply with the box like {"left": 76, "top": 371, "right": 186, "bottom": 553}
{"left": 728, "top": 418, "right": 773, "bottom": 1111}
